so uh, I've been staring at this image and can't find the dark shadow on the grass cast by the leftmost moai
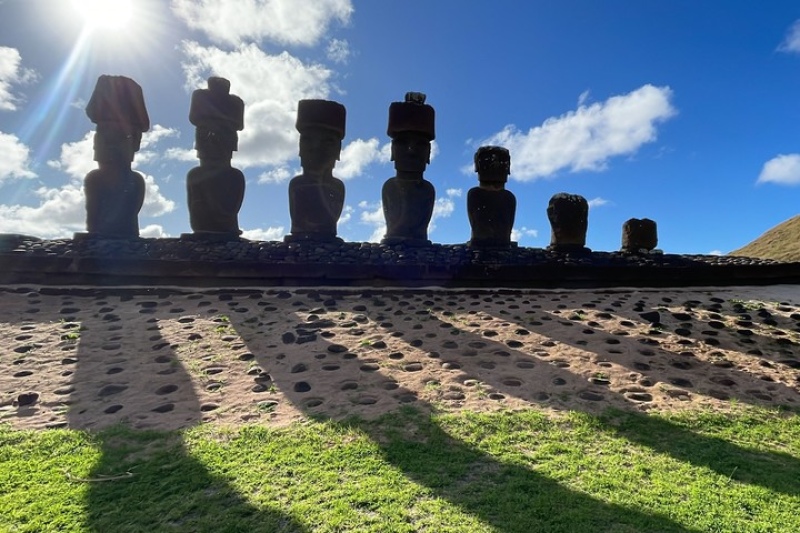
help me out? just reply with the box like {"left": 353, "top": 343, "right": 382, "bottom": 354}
{"left": 87, "top": 427, "right": 306, "bottom": 533}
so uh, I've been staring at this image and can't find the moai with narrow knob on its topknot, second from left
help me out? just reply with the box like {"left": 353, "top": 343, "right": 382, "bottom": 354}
{"left": 184, "top": 77, "right": 245, "bottom": 240}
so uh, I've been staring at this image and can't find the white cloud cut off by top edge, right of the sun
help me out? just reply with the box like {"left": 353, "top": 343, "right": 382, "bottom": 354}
{"left": 172, "top": 0, "right": 353, "bottom": 46}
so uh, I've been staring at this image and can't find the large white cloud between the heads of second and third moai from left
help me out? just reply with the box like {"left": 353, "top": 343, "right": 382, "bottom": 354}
{"left": 183, "top": 42, "right": 333, "bottom": 168}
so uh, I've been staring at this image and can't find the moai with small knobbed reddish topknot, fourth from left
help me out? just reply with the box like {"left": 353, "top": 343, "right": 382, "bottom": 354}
{"left": 381, "top": 93, "right": 436, "bottom": 246}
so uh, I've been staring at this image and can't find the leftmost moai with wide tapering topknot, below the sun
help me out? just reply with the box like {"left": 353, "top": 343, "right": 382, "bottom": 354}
{"left": 83, "top": 75, "right": 150, "bottom": 239}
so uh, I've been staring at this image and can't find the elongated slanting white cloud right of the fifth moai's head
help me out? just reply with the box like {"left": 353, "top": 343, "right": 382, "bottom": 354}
{"left": 479, "top": 85, "right": 676, "bottom": 181}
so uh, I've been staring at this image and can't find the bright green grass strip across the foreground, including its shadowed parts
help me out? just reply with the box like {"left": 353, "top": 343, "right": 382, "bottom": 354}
{"left": 0, "top": 409, "right": 800, "bottom": 533}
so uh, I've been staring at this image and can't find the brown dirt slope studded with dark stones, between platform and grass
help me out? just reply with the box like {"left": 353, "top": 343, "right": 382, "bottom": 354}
{"left": 0, "top": 285, "right": 800, "bottom": 429}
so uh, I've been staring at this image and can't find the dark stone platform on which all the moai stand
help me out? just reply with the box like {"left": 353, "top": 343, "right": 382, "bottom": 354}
{"left": 0, "top": 234, "right": 800, "bottom": 288}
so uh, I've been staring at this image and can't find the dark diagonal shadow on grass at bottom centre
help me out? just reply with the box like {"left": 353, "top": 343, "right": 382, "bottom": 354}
{"left": 330, "top": 408, "right": 693, "bottom": 533}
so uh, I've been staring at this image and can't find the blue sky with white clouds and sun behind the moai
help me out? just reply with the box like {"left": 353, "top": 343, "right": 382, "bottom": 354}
{"left": 0, "top": 0, "right": 800, "bottom": 254}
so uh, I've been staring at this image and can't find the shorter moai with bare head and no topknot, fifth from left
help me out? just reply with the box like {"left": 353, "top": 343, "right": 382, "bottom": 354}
{"left": 467, "top": 146, "right": 517, "bottom": 248}
